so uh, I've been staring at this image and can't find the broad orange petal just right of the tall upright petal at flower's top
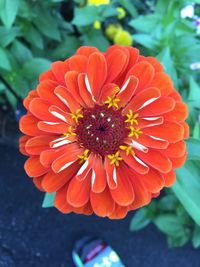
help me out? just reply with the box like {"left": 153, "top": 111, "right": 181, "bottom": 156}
{"left": 106, "top": 49, "right": 128, "bottom": 83}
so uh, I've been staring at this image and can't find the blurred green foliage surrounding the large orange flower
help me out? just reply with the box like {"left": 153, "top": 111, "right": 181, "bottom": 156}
{"left": 0, "top": 0, "right": 200, "bottom": 248}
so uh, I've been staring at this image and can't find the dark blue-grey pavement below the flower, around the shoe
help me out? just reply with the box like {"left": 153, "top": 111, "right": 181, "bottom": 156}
{"left": 0, "top": 144, "right": 200, "bottom": 267}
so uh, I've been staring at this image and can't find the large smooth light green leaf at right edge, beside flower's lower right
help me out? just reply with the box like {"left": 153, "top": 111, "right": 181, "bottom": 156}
{"left": 172, "top": 161, "right": 200, "bottom": 225}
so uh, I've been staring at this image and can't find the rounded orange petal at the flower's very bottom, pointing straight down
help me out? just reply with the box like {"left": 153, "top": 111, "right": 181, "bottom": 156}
{"left": 90, "top": 187, "right": 115, "bottom": 217}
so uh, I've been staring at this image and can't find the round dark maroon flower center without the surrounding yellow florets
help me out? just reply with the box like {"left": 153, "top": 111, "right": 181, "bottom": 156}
{"left": 75, "top": 105, "right": 129, "bottom": 156}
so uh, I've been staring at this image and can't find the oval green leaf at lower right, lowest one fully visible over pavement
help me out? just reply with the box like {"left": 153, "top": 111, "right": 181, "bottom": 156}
{"left": 154, "top": 214, "right": 184, "bottom": 236}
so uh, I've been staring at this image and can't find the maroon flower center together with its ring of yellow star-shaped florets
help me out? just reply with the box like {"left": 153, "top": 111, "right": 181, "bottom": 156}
{"left": 64, "top": 96, "right": 142, "bottom": 166}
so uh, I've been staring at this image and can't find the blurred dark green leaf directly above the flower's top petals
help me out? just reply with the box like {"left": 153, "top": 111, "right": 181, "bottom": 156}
{"left": 82, "top": 30, "right": 110, "bottom": 51}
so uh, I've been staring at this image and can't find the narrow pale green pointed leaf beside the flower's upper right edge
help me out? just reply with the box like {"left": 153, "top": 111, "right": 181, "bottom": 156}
{"left": 156, "top": 47, "right": 178, "bottom": 88}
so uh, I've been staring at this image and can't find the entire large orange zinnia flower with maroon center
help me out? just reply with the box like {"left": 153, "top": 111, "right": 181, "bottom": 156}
{"left": 20, "top": 45, "right": 189, "bottom": 219}
